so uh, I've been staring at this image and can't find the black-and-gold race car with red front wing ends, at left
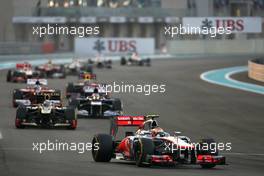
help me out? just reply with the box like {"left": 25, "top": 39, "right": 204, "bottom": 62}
{"left": 15, "top": 100, "right": 77, "bottom": 129}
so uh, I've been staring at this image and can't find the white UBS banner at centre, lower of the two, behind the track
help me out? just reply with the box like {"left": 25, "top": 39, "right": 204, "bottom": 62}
{"left": 74, "top": 38, "right": 155, "bottom": 55}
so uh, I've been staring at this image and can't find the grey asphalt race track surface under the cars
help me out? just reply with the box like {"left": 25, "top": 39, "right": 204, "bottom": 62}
{"left": 0, "top": 57, "right": 264, "bottom": 176}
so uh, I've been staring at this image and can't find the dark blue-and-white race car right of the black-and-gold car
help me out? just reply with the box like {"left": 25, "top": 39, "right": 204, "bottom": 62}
{"left": 69, "top": 88, "right": 122, "bottom": 118}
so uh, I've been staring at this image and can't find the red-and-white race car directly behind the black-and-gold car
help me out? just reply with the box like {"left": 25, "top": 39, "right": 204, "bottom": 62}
{"left": 12, "top": 79, "right": 61, "bottom": 107}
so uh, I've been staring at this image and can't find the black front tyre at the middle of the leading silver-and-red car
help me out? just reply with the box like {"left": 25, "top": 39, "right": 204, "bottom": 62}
{"left": 135, "top": 138, "right": 155, "bottom": 167}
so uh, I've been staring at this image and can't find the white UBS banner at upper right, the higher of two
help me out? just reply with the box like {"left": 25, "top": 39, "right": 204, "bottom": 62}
{"left": 182, "top": 17, "right": 262, "bottom": 33}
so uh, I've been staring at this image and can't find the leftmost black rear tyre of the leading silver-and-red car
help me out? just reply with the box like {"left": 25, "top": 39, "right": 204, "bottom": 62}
{"left": 92, "top": 134, "right": 114, "bottom": 162}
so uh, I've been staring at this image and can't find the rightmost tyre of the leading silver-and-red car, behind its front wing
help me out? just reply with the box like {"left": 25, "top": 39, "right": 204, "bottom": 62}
{"left": 197, "top": 138, "right": 218, "bottom": 169}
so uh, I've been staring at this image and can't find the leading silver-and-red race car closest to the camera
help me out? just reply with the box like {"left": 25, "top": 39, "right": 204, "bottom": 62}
{"left": 92, "top": 116, "right": 225, "bottom": 168}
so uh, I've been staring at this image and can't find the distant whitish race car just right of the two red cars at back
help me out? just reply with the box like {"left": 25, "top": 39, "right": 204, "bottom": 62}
{"left": 65, "top": 59, "right": 93, "bottom": 75}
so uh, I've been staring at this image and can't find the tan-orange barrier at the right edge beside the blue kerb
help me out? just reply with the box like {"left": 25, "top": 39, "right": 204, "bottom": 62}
{"left": 248, "top": 59, "right": 264, "bottom": 82}
